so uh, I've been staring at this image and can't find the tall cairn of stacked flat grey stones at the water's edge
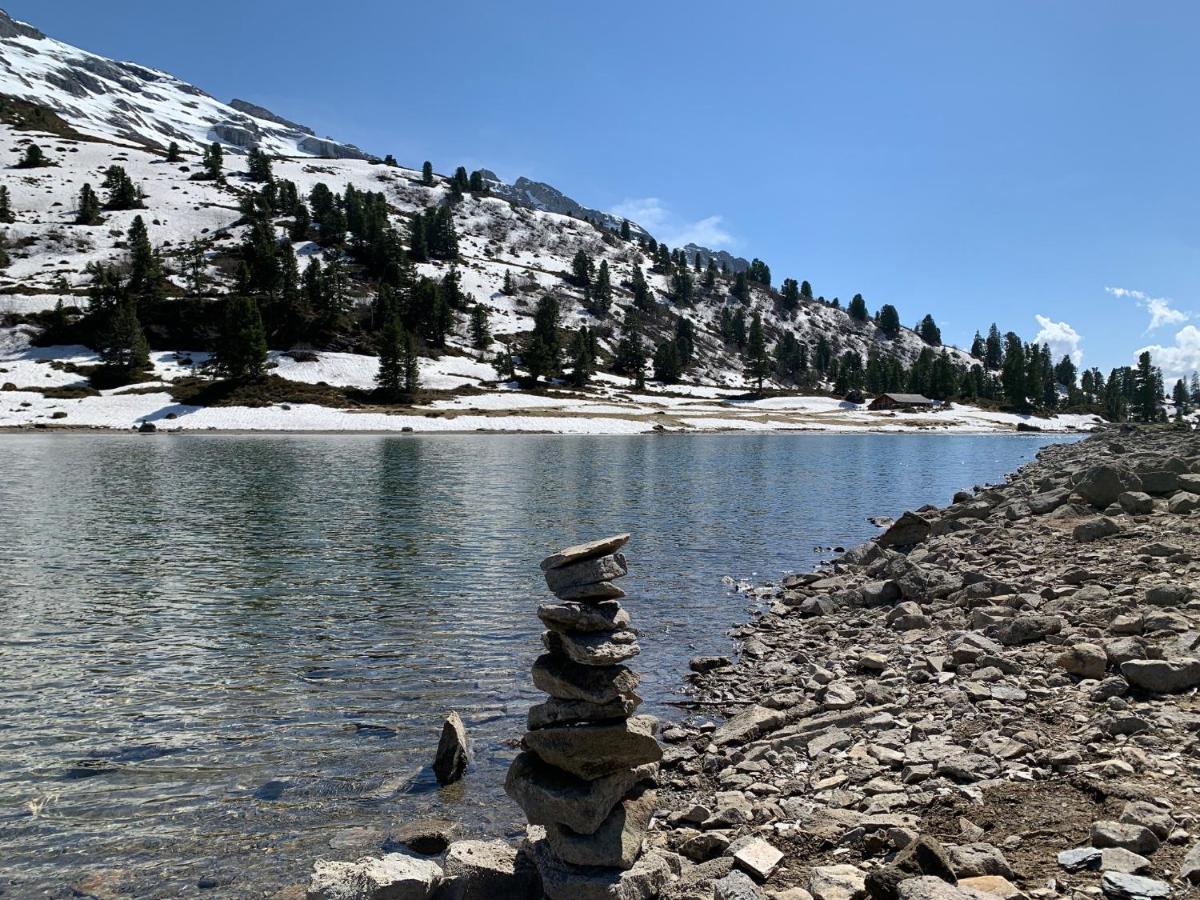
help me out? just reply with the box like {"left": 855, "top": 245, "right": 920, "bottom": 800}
{"left": 504, "top": 534, "right": 662, "bottom": 900}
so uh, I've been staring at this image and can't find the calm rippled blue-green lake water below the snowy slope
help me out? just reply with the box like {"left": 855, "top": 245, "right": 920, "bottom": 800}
{"left": 0, "top": 434, "right": 1080, "bottom": 896}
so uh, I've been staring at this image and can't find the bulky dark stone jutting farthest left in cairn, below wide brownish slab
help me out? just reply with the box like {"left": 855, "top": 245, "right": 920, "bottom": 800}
{"left": 504, "top": 752, "right": 658, "bottom": 834}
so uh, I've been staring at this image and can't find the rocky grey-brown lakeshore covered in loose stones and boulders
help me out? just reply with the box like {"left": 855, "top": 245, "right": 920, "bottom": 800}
{"left": 292, "top": 427, "right": 1200, "bottom": 900}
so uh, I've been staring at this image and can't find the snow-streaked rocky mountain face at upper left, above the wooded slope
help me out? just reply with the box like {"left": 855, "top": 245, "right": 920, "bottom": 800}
{"left": 0, "top": 10, "right": 366, "bottom": 158}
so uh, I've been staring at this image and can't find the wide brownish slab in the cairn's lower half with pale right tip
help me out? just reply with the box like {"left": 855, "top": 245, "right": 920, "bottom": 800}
{"left": 524, "top": 715, "right": 662, "bottom": 779}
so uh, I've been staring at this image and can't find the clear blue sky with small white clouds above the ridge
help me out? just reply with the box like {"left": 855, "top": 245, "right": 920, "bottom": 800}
{"left": 6, "top": 0, "right": 1200, "bottom": 374}
